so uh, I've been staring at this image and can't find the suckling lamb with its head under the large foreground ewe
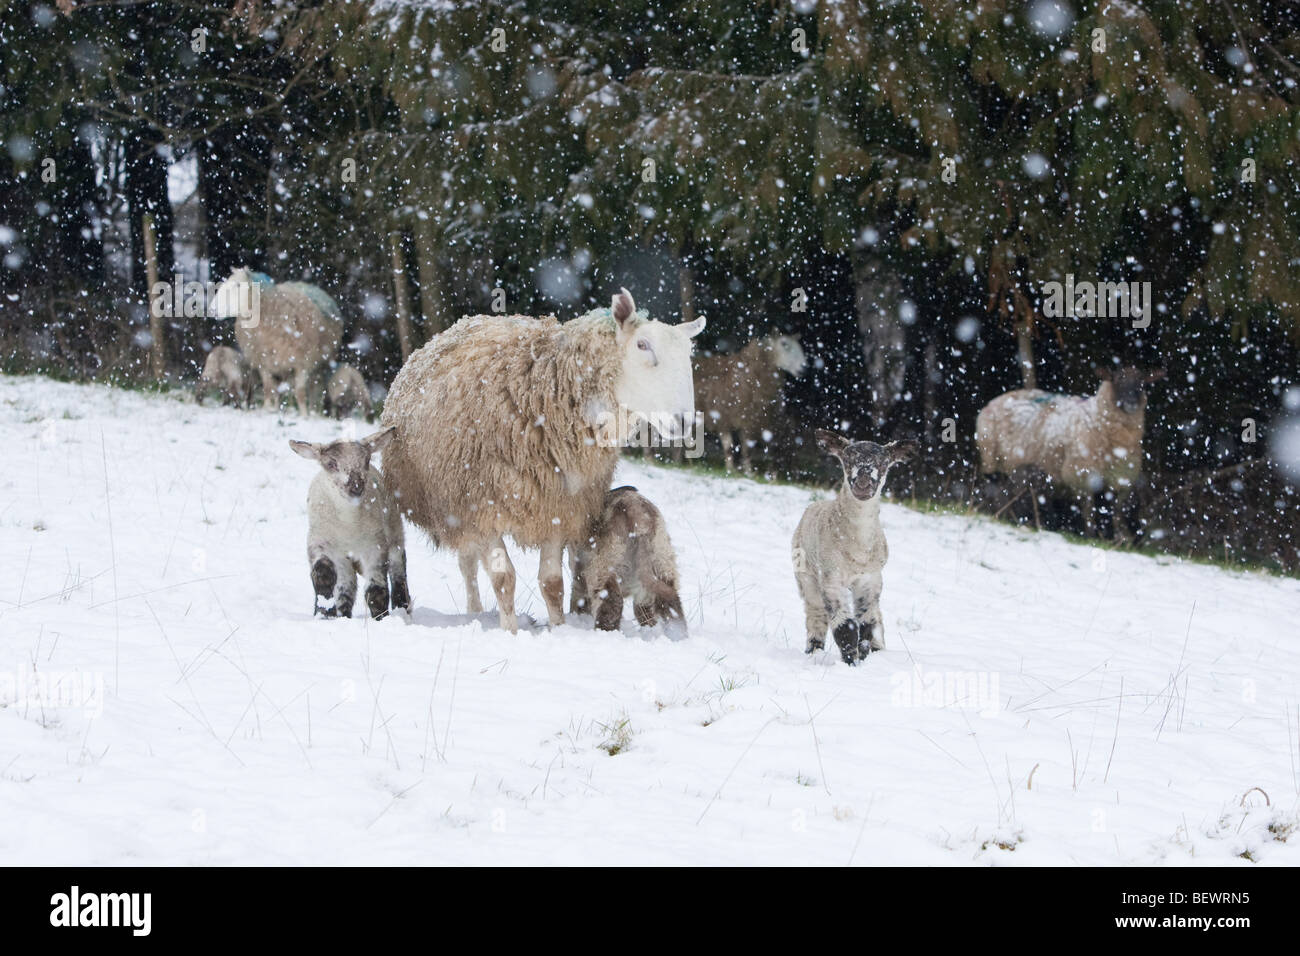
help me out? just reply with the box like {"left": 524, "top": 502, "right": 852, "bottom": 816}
{"left": 569, "top": 485, "right": 686, "bottom": 637}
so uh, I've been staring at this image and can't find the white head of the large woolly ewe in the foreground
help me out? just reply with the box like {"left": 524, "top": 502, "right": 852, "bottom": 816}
{"left": 611, "top": 289, "right": 705, "bottom": 438}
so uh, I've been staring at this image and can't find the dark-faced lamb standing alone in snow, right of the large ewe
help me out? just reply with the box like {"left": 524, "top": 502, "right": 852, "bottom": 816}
{"left": 792, "top": 429, "right": 918, "bottom": 665}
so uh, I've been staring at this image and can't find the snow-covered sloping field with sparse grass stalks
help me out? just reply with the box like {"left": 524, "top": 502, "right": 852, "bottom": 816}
{"left": 0, "top": 377, "right": 1300, "bottom": 865}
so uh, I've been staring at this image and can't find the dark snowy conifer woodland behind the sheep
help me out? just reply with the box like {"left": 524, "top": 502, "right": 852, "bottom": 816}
{"left": 0, "top": 0, "right": 1300, "bottom": 571}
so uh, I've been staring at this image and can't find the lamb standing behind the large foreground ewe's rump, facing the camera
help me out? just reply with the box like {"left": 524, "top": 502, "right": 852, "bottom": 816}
{"left": 289, "top": 428, "right": 411, "bottom": 619}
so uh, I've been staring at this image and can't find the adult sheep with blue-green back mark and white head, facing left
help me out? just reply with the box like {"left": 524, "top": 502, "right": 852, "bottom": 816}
{"left": 215, "top": 268, "right": 343, "bottom": 415}
